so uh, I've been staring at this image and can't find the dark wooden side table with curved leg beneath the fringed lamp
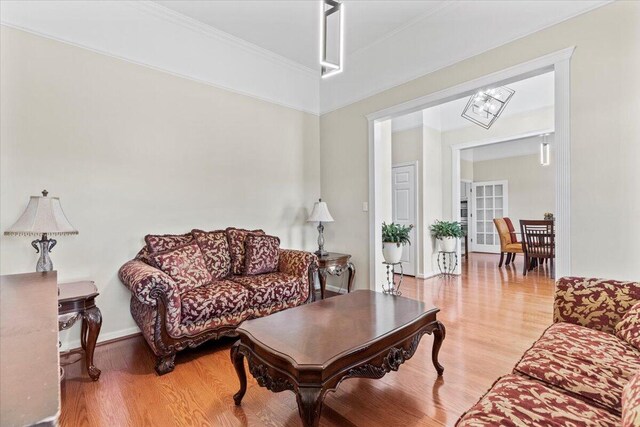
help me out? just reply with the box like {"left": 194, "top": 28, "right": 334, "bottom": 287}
{"left": 58, "top": 281, "right": 102, "bottom": 381}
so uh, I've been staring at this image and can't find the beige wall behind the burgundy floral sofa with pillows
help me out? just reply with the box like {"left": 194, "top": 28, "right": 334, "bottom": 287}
{"left": 0, "top": 26, "right": 320, "bottom": 346}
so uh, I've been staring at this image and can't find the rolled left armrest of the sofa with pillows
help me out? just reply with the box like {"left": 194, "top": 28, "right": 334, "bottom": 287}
{"left": 118, "top": 259, "right": 179, "bottom": 306}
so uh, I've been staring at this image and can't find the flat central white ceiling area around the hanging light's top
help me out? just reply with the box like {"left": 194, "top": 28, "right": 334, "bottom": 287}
{"left": 154, "top": 0, "right": 446, "bottom": 70}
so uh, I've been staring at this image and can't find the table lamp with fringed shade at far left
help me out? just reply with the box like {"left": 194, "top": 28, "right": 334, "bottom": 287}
{"left": 4, "top": 190, "right": 78, "bottom": 272}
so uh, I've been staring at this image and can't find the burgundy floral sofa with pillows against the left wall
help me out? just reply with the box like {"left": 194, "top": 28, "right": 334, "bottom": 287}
{"left": 118, "top": 228, "right": 317, "bottom": 375}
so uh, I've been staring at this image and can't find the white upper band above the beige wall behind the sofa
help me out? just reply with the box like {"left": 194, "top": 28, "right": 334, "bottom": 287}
{"left": 0, "top": 1, "right": 320, "bottom": 115}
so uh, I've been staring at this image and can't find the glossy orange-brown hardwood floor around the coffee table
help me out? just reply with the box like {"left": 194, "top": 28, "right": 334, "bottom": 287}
{"left": 60, "top": 254, "right": 554, "bottom": 427}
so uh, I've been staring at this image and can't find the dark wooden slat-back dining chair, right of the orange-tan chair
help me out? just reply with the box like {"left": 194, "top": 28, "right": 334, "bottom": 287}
{"left": 520, "top": 219, "right": 556, "bottom": 277}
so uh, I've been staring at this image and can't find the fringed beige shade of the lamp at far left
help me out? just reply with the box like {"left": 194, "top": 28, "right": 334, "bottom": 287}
{"left": 4, "top": 190, "right": 78, "bottom": 236}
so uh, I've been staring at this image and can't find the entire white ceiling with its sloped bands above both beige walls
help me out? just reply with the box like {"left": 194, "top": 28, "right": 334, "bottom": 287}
{"left": 0, "top": 0, "right": 609, "bottom": 114}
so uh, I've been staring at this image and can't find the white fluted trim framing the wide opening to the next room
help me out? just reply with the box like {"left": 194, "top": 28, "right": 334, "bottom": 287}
{"left": 365, "top": 46, "right": 576, "bottom": 290}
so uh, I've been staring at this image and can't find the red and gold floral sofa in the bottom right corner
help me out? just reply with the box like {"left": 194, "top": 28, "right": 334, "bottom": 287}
{"left": 456, "top": 277, "right": 640, "bottom": 427}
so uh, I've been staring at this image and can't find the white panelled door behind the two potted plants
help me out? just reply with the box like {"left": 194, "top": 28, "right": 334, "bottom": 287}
{"left": 391, "top": 164, "right": 418, "bottom": 276}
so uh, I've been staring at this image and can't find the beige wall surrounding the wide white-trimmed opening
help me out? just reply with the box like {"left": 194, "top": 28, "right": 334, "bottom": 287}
{"left": 320, "top": 2, "right": 640, "bottom": 287}
